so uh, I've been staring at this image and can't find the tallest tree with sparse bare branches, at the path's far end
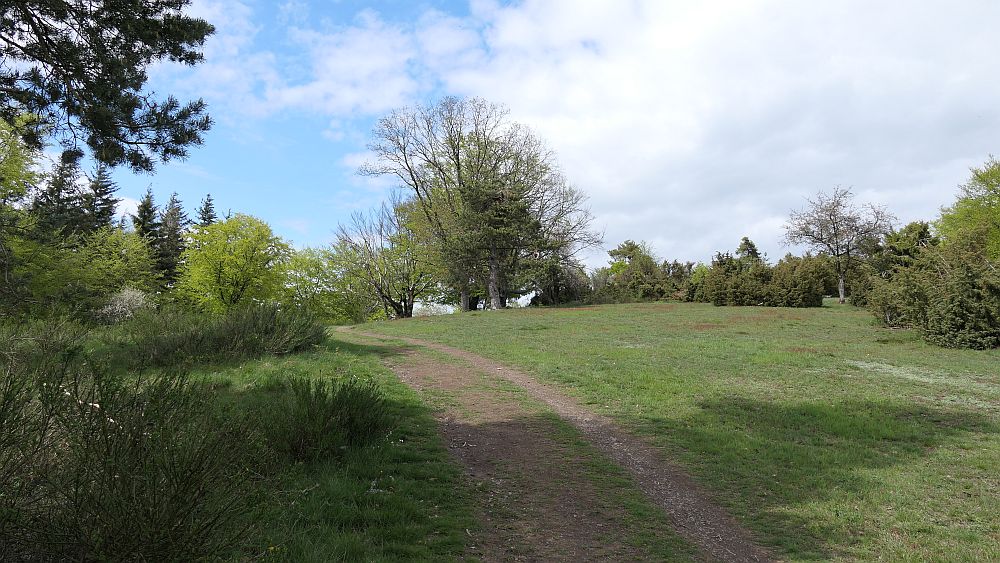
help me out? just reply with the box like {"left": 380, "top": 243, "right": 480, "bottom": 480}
{"left": 360, "top": 97, "right": 600, "bottom": 310}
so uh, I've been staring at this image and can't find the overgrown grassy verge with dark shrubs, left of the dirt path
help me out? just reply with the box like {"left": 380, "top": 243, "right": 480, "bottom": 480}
{"left": 0, "top": 311, "right": 476, "bottom": 562}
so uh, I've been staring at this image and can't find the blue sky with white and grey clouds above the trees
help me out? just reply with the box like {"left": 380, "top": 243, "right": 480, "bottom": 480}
{"left": 109, "top": 0, "right": 1000, "bottom": 267}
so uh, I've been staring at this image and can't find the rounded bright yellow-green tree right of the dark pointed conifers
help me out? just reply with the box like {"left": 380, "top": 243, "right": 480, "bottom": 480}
{"left": 176, "top": 213, "right": 291, "bottom": 312}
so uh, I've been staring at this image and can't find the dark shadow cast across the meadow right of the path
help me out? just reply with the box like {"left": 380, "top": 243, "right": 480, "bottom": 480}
{"left": 633, "top": 397, "right": 998, "bottom": 559}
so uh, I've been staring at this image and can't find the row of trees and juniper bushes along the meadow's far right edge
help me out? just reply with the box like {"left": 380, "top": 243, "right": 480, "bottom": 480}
{"left": 568, "top": 157, "right": 1000, "bottom": 349}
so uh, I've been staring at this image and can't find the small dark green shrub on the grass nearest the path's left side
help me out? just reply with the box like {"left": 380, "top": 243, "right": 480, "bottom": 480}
{"left": 269, "top": 377, "right": 391, "bottom": 461}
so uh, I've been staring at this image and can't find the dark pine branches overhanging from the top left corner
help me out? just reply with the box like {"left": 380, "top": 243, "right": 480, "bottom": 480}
{"left": 0, "top": 0, "right": 213, "bottom": 171}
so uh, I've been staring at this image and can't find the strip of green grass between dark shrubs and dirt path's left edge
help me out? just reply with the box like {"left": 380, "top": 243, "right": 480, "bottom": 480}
{"left": 194, "top": 341, "right": 475, "bottom": 562}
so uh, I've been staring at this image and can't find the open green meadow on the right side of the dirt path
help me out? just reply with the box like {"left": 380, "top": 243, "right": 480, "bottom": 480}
{"left": 365, "top": 304, "right": 1000, "bottom": 560}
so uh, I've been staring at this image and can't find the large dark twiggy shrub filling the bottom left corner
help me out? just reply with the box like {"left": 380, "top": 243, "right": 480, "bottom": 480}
{"left": 0, "top": 327, "right": 253, "bottom": 561}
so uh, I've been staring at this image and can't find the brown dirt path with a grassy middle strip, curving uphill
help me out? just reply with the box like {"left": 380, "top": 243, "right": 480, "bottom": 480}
{"left": 341, "top": 328, "right": 771, "bottom": 561}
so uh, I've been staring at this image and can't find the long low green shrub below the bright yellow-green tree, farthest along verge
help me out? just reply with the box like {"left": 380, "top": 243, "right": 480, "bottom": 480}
{"left": 99, "top": 304, "right": 326, "bottom": 369}
